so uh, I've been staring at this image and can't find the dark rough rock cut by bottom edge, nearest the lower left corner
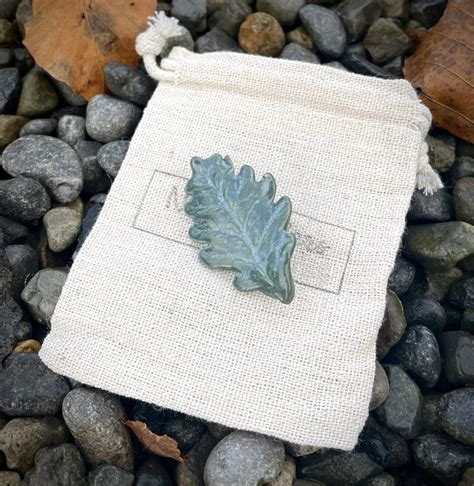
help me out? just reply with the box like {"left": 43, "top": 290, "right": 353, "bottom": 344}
{"left": 22, "top": 444, "right": 87, "bottom": 486}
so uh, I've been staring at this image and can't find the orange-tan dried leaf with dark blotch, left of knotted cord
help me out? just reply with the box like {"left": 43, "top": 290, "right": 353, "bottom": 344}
{"left": 23, "top": 0, "right": 156, "bottom": 99}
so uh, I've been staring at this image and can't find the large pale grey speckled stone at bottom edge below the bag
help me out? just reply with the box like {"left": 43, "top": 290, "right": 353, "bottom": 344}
{"left": 204, "top": 431, "right": 285, "bottom": 485}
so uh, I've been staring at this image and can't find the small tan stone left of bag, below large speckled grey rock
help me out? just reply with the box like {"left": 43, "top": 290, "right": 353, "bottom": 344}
{"left": 43, "top": 207, "right": 82, "bottom": 253}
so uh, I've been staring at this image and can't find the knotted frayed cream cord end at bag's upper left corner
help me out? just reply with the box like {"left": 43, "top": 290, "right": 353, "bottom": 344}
{"left": 135, "top": 12, "right": 183, "bottom": 81}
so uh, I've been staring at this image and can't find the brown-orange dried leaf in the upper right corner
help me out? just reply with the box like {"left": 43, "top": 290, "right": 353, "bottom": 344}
{"left": 403, "top": 0, "right": 474, "bottom": 143}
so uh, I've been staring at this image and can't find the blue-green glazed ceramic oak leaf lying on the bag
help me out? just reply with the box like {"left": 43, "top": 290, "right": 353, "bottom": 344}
{"left": 185, "top": 154, "right": 296, "bottom": 304}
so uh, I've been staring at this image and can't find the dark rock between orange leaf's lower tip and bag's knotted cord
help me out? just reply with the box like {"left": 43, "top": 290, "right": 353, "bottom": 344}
{"left": 104, "top": 61, "right": 156, "bottom": 106}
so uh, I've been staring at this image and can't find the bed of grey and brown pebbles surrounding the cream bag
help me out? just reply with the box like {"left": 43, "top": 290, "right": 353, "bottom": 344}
{"left": 0, "top": 0, "right": 474, "bottom": 486}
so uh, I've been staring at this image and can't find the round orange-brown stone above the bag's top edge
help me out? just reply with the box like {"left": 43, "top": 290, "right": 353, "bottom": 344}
{"left": 239, "top": 12, "right": 285, "bottom": 56}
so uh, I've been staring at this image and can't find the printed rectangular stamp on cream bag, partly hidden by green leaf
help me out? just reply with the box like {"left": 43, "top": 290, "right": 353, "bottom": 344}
{"left": 132, "top": 170, "right": 356, "bottom": 295}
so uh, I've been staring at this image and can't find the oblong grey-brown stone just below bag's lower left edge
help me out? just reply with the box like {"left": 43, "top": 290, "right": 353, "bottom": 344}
{"left": 63, "top": 387, "right": 133, "bottom": 471}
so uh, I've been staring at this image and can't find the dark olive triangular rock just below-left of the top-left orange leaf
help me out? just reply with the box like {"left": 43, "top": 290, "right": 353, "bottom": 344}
{"left": 17, "top": 68, "right": 59, "bottom": 117}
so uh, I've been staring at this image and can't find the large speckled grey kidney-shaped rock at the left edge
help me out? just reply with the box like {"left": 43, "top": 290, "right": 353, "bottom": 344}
{"left": 2, "top": 135, "right": 83, "bottom": 203}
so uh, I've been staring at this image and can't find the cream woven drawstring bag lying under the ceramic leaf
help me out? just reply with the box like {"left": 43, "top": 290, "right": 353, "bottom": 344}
{"left": 40, "top": 14, "right": 441, "bottom": 450}
